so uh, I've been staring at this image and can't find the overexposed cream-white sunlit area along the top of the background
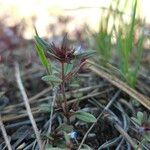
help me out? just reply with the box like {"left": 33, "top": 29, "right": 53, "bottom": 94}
{"left": 0, "top": 0, "right": 150, "bottom": 39}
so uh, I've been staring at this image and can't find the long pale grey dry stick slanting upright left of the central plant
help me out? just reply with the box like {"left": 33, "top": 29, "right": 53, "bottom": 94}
{"left": 15, "top": 63, "right": 43, "bottom": 150}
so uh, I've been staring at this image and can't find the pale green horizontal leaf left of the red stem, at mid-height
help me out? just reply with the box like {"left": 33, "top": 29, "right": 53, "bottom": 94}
{"left": 42, "top": 75, "right": 62, "bottom": 83}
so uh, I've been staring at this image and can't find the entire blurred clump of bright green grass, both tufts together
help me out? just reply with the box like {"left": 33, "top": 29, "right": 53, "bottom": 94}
{"left": 94, "top": 0, "right": 144, "bottom": 87}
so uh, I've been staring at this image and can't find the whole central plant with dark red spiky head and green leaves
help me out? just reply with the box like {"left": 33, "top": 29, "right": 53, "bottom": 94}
{"left": 35, "top": 31, "right": 96, "bottom": 146}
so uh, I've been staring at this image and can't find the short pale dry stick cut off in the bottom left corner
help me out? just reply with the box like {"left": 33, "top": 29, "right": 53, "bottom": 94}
{"left": 0, "top": 115, "right": 12, "bottom": 150}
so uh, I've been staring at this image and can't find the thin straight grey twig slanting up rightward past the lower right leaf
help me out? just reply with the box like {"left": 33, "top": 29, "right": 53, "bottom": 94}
{"left": 78, "top": 90, "right": 120, "bottom": 150}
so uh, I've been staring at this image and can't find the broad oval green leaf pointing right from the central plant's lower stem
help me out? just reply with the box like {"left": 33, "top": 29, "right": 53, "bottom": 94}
{"left": 74, "top": 111, "right": 96, "bottom": 122}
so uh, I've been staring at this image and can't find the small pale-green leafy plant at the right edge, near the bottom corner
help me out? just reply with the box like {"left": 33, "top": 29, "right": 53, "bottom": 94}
{"left": 131, "top": 111, "right": 150, "bottom": 143}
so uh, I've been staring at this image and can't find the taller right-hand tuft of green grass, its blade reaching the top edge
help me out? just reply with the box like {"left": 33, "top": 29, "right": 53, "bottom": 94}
{"left": 116, "top": 1, "right": 144, "bottom": 87}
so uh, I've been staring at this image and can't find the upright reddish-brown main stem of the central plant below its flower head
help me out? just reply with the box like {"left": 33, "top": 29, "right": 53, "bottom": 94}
{"left": 61, "top": 62, "right": 69, "bottom": 122}
